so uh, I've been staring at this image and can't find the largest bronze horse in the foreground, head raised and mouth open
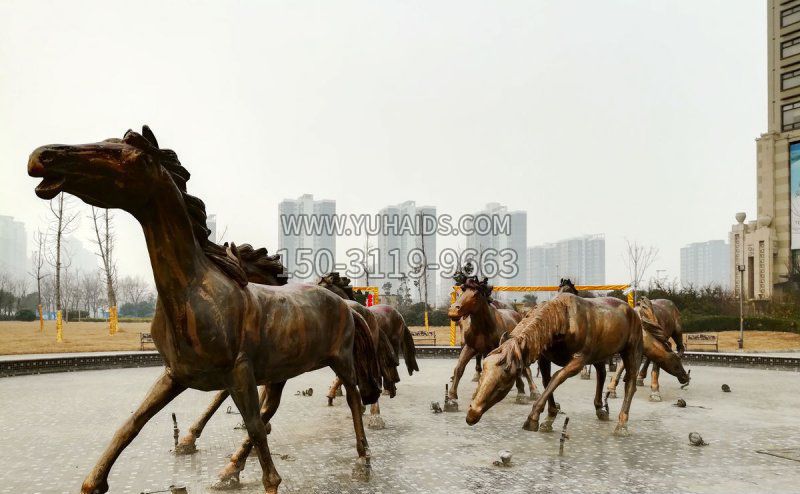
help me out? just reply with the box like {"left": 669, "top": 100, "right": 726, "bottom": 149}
{"left": 28, "top": 126, "right": 381, "bottom": 494}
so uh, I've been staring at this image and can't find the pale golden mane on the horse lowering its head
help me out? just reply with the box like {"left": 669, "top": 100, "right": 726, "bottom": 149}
{"left": 491, "top": 297, "right": 569, "bottom": 366}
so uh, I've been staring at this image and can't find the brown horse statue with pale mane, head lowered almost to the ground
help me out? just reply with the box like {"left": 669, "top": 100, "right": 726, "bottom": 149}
{"left": 467, "top": 293, "right": 642, "bottom": 435}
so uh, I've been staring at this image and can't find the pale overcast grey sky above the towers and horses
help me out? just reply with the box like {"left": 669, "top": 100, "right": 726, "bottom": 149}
{"left": 0, "top": 0, "right": 767, "bottom": 282}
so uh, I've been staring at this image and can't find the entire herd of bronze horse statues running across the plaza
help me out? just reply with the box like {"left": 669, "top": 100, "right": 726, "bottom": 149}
{"left": 28, "top": 126, "right": 689, "bottom": 494}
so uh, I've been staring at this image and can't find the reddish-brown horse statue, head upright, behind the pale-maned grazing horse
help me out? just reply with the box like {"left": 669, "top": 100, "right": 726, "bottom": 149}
{"left": 447, "top": 276, "right": 538, "bottom": 400}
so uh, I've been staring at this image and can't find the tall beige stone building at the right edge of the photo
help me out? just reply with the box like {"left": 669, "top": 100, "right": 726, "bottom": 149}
{"left": 728, "top": 0, "right": 800, "bottom": 300}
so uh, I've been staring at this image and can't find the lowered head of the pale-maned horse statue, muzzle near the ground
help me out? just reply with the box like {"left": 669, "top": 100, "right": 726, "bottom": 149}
{"left": 467, "top": 332, "right": 527, "bottom": 425}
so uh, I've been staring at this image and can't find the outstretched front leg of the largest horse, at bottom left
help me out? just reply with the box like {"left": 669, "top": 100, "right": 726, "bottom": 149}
{"left": 81, "top": 371, "right": 186, "bottom": 494}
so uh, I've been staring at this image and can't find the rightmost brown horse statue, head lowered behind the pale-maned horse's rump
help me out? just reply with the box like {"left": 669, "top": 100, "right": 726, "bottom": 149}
{"left": 608, "top": 297, "right": 689, "bottom": 401}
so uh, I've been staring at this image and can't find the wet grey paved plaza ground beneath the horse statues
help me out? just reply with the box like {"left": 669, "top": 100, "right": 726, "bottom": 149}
{"left": 0, "top": 359, "right": 800, "bottom": 494}
